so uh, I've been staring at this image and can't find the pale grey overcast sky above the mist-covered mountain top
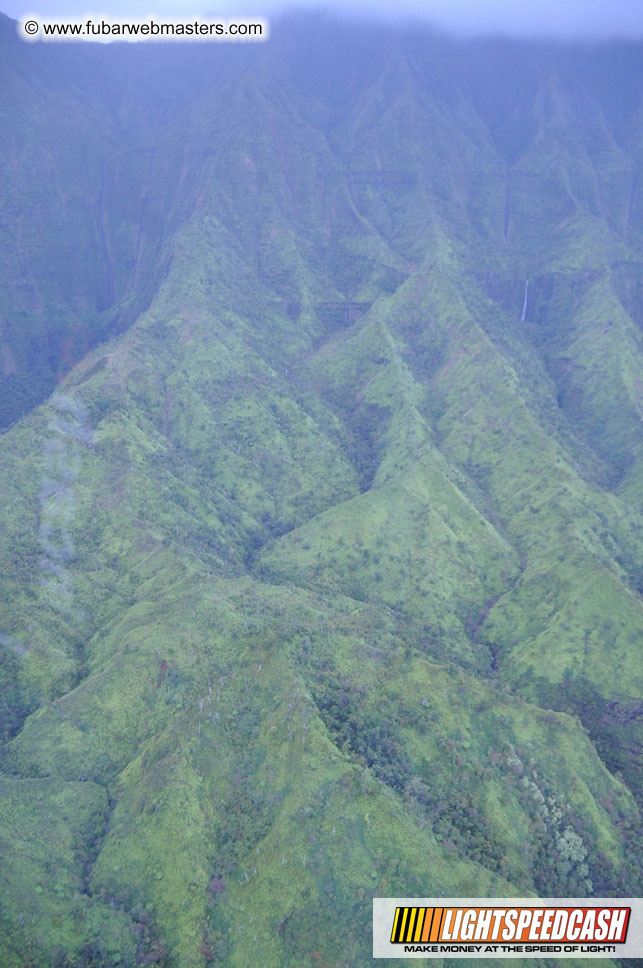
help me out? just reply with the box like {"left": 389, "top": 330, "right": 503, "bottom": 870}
{"left": 5, "top": 0, "right": 643, "bottom": 39}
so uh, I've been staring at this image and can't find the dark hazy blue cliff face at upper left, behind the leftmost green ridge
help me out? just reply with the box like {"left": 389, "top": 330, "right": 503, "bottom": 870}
{"left": 0, "top": 14, "right": 250, "bottom": 427}
